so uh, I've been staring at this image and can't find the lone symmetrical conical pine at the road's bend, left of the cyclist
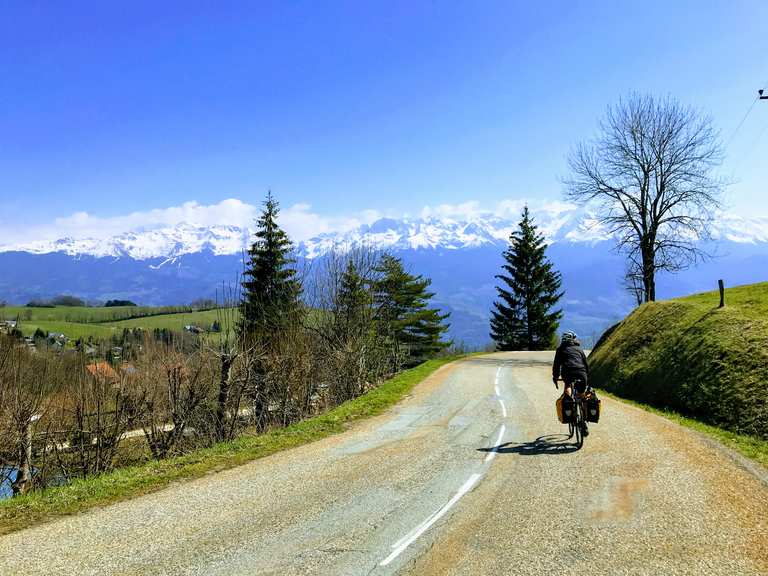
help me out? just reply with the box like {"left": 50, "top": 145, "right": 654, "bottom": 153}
{"left": 491, "top": 206, "right": 563, "bottom": 350}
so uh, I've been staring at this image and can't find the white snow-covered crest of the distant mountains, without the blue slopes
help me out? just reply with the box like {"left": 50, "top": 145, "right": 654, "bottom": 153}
{"left": 0, "top": 209, "right": 768, "bottom": 260}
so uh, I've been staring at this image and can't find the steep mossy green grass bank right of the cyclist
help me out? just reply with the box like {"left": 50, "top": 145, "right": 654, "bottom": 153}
{"left": 590, "top": 282, "right": 768, "bottom": 440}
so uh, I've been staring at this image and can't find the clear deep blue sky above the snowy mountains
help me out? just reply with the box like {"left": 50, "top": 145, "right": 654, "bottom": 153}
{"left": 0, "top": 0, "right": 768, "bottom": 242}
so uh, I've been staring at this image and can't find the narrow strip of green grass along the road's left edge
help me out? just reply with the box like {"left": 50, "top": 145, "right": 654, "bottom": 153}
{"left": 0, "top": 357, "right": 458, "bottom": 535}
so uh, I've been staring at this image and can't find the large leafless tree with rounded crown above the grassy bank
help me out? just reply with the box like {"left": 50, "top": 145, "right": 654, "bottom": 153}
{"left": 565, "top": 94, "right": 724, "bottom": 302}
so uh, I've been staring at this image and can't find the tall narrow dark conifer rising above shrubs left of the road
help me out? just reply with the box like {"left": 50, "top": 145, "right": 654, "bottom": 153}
{"left": 239, "top": 192, "right": 302, "bottom": 338}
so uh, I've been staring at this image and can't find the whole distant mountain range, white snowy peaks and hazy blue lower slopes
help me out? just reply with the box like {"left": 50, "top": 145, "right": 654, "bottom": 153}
{"left": 0, "top": 208, "right": 768, "bottom": 344}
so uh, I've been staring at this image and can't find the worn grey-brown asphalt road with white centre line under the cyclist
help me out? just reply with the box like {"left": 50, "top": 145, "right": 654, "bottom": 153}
{"left": 0, "top": 353, "right": 768, "bottom": 576}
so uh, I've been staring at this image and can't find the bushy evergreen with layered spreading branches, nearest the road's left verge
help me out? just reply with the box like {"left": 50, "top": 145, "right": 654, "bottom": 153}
{"left": 373, "top": 255, "right": 450, "bottom": 364}
